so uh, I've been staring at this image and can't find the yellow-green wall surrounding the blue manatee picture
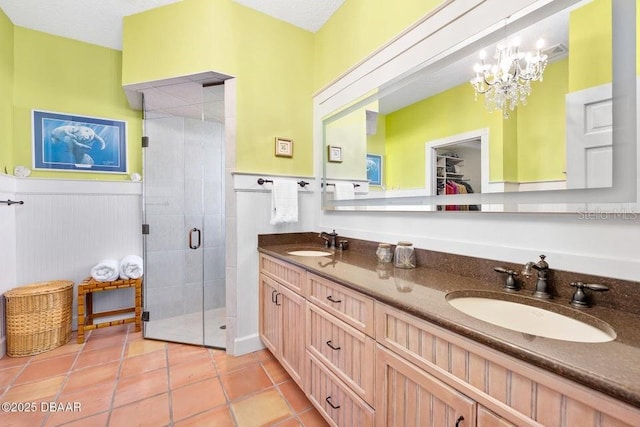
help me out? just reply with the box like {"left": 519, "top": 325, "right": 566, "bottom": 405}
{"left": 13, "top": 26, "right": 142, "bottom": 181}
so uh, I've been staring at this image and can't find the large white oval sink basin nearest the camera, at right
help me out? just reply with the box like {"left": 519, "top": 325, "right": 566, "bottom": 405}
{"left": 447, "top": 294, "right": 616, "bottom": 343}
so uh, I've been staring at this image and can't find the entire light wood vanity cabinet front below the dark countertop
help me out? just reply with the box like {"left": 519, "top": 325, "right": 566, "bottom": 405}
{"left": 260, "top": 254, "right": 640, "bottom": 427}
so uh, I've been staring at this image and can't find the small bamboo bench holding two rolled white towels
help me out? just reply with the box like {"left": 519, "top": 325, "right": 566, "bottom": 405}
{"left": 78, "top": 277, "right": 142, "bottom": 344}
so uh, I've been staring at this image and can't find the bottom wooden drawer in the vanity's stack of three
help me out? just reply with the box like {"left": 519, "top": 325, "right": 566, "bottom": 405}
{"left": 307, "top": 352, "right": 374, "bottom": 427}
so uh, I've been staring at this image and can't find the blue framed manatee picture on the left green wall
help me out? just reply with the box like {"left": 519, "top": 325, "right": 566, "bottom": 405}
{"left": 31, "top": 110, "right": 127, "bottom": 173}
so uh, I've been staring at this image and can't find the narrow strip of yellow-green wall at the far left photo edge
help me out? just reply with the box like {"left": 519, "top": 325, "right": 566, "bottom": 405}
{"left": 0, "top": 10, "right": 14, "bottom": 173}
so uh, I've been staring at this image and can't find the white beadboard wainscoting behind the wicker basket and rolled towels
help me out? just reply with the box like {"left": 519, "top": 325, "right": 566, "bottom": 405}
{"left": 0, "top": 177, "right": 142, "bottom": 358}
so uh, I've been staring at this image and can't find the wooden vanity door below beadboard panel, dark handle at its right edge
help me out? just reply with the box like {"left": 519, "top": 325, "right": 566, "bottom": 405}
{"left": 376, "top": 345, "right": 476, "bottom": 427}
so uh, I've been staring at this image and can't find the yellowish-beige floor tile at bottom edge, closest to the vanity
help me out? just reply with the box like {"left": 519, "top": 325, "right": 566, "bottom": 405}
{"left": 231, "top": 388, "right": 293, "bottom": 427}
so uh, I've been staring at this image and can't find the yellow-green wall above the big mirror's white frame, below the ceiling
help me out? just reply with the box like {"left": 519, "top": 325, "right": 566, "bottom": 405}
{"left": 314, "top": 0, "right": 444, "bottom": 90}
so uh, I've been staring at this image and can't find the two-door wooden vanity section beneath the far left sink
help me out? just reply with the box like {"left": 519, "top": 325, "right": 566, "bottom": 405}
{"left": 259, "top": 255, "right": 305, "bottom": 388}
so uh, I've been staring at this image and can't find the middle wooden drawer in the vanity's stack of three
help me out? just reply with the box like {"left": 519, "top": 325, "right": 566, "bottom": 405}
{"left": 306, "top": 303, "right": 375, "bottom": 405}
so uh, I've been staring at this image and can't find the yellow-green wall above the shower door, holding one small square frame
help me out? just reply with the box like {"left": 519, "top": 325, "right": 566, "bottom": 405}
{"left": 123, "top": 0, "right": 314, "bottom": 175}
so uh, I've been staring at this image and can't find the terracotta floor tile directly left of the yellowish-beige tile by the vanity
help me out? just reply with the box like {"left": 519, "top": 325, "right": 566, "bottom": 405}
{"left": 171, "top": 378, "right": 226, "bottom": 421}
